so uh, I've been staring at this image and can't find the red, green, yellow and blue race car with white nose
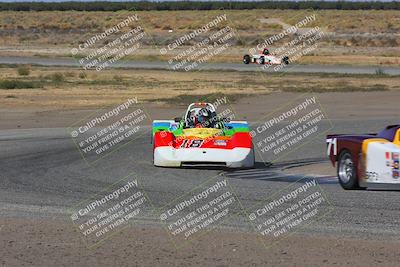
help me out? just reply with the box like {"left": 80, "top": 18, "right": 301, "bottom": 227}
{"left": 152, "top": 103, "right": 254, "bottom": 168}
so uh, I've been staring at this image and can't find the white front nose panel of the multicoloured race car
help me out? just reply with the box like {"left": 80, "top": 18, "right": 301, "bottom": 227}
{"left": 154, "top": 146, "right": 254, "bottom": 168}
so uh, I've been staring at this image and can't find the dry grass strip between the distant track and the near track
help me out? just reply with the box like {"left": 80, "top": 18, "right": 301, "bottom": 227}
{"left": 0, "top": 66, "right": 400, "bottom": 108}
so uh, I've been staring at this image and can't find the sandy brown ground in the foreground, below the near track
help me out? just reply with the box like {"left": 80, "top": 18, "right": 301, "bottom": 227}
{"left": 0, "top": 218, "right": 400, "bottom": 266}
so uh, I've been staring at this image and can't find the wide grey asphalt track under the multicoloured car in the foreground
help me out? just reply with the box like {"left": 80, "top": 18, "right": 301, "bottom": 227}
{"left": 0, "top": 120, "right": 400, "bottom": 241}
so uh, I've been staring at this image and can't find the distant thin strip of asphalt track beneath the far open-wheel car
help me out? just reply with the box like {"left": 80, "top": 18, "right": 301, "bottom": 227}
{"left": 0, "top": 57, "right": 400, "bottom": 75}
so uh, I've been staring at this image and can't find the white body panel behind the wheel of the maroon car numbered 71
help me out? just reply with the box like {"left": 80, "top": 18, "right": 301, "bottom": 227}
{"left": 365, "top": 142, "right": 400, "bottom": 184}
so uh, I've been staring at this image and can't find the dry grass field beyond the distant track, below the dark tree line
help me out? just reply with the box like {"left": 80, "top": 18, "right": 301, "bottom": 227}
{"left": 0, "top": 10, "right": 400, "bottom": 65}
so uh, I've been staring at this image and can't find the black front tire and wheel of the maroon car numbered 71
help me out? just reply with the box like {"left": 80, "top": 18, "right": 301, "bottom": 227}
{"left": 337, "top": 149, "right": 359, "bottom": 190}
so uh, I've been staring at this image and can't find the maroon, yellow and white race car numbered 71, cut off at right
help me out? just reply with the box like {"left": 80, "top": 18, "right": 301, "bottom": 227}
{"left": 326, "top": 125, "right": 400, "bottom": 190}
